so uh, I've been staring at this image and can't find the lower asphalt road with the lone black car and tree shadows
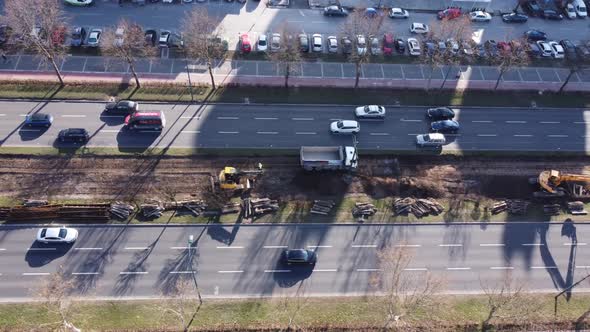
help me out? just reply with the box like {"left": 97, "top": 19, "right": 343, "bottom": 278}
{"left": 0, "top": 223, "right": 590, "bottom": 301}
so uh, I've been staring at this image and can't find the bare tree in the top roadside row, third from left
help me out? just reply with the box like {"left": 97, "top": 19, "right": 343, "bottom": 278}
{"left": 181, "top": 7, "right": 228, "bottom": 90}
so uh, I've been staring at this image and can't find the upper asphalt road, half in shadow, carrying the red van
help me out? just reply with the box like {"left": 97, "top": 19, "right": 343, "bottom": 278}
{"left": 0, "top": 101, "right": 590, "bottom": 154}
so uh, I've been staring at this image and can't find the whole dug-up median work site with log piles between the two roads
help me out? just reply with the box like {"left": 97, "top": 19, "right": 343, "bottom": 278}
{"left": 0, "top": 156, "right": 590, "bottom": 223}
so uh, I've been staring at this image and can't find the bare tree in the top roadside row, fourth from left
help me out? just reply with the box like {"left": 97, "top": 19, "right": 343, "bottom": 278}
{"left": 268, "top": 28, "right": 301, "bottom": 88}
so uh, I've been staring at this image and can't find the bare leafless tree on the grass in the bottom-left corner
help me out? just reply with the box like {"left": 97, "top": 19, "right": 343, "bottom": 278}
{"left": 33, "top": 266, "right": 79, "bottom": 331}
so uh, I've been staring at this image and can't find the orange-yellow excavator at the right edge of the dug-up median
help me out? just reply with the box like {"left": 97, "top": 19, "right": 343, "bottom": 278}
{"left": 537, "top": 170, "right": 590, "bottom": 198}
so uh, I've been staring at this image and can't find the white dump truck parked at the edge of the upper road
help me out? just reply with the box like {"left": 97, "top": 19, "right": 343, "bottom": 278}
{"left": 300, "top": 146, "right": 358, "bottom": 171}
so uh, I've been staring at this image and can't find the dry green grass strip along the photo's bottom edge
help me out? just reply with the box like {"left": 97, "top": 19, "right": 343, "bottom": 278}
{"left": 0, "top": 294, "right": 590, "bottom": 331}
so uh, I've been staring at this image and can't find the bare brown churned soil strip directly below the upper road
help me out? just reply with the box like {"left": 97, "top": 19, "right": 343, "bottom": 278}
{"left": 0, "top": 156, "right": 590, "bottom": 201}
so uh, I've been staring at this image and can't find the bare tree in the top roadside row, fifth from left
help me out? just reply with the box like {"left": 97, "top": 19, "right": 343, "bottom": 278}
{"left": 342, "top": 10, "right": 382, "bottom": 89}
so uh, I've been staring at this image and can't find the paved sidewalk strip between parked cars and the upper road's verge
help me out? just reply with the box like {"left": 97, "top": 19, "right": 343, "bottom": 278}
{"left": 0, "top": 55, "right": 590, "bottom": 91}
